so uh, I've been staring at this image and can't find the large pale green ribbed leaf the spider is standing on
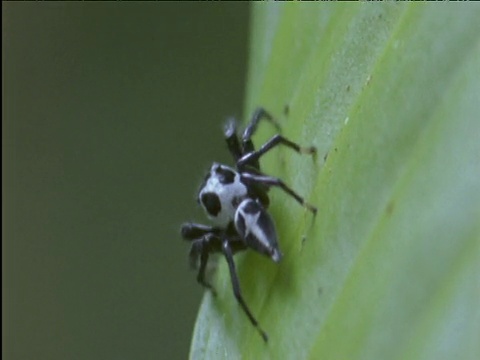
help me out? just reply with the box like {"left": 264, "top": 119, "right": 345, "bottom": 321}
{"left": 191, "top": 3, "right": 480, "bottom": 360}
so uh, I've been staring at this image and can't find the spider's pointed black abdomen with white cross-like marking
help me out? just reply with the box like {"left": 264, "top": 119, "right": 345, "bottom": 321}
{"left": 235, "top": 198, "right": 282, "bottom": 262}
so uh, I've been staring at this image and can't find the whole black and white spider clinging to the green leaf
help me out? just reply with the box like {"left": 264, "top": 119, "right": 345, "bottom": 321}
{"left": 181, "top": 108, "right": 317, "bottom": 342}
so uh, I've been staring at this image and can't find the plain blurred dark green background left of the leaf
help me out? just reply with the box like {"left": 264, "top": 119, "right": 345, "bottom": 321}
{"left": 2, "top": 2, "right": 249, "bottom": 359}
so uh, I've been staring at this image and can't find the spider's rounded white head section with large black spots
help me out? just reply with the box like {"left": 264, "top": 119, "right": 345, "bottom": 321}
{"left": 198, "top": 163, "right": 247, "bottom": 226}
